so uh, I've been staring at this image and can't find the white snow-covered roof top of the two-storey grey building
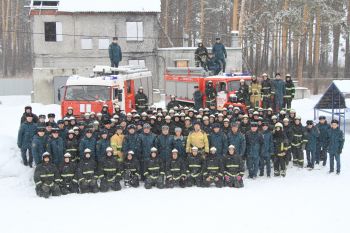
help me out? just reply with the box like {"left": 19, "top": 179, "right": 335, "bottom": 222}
{"left": 58, "top": 0, "right": 161, "bottom": 12}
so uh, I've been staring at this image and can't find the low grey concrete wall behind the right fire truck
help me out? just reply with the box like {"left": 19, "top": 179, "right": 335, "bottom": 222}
{"left": 157, "top": 47, "right": 242, "bottom": 89}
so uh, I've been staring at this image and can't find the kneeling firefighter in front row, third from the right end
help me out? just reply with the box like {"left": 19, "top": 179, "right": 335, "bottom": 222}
{"left": 187, "top": 146, "right": 203, "bottom": 187}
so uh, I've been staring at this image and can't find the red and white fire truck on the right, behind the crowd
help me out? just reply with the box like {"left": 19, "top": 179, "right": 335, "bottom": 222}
{"left": 164, "top": 67, "right": 251, "bottom": 112}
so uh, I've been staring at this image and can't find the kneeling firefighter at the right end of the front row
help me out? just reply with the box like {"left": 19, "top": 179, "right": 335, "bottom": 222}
{"left": 223, "top": 145, "right": 244, "bottom": 188}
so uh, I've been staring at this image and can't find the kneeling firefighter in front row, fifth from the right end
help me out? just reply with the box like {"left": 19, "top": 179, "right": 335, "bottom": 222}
{"left": 144, "top": 147, "right": 165, "bottom": 189}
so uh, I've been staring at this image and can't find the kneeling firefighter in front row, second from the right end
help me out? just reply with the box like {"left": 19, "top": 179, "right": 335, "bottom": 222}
{"left": 202, "top": 147, "right": 223, "bottom": 188}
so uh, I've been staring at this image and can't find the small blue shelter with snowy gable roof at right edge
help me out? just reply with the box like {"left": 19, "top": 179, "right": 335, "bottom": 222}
{"left": 314, "top": 80, "right": 350, "bottom": 132}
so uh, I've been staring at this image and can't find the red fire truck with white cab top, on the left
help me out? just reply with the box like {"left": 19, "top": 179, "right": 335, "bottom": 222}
{"left": 58, "top": 66, "right": 152, "bottom": 118}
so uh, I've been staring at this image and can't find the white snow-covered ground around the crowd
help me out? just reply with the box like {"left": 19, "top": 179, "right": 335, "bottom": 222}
{"left": 0, "top": 96, "right": 350, "bottom": 233}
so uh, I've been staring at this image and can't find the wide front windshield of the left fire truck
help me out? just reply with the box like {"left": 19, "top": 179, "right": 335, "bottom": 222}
{"left": 65, "top": 86, "right": 111, "bottom": 101}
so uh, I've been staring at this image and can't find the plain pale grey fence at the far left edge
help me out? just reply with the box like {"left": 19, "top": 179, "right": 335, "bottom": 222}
{"left": 0, "top": 78, "right": 33, "bottom": 96}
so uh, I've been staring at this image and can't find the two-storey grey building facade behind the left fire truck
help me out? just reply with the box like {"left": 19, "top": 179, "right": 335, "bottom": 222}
{"left": 30, "top": 0, "right": 160, "bottom": 104}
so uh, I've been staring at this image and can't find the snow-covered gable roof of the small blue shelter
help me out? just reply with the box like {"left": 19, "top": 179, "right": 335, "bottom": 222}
{"left": 315, "top": 80, "right": 350, "bottom": 109}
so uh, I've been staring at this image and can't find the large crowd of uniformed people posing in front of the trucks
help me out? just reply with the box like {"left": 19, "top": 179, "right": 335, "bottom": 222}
{"left": 18, "top": 73, "right": 344, "bottom": 197}
